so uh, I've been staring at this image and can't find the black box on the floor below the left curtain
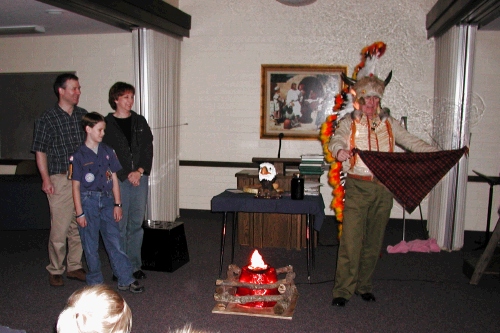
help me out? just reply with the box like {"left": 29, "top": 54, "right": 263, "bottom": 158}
{"left": 141, "top": 220, "right": 189, "bottom": 272}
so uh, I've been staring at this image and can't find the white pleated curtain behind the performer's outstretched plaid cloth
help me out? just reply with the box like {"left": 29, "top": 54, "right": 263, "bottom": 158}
{"left": 428, "top": 25, "right": 477, "bottom": 250}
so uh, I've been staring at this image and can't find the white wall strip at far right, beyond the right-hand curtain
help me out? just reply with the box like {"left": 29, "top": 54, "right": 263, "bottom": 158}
{"left": 465, "top": 30, "right": 500, "bottom": 230}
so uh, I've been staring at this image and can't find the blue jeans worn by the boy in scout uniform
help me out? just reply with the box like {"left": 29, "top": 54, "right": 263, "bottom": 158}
{"left": 78, "top": 191, "right": 134, "bottom": 286}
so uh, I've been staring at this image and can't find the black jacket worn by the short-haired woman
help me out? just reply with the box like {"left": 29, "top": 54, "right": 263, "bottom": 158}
{"left": 102, "top": 111, "right": 153, "bottom": 181}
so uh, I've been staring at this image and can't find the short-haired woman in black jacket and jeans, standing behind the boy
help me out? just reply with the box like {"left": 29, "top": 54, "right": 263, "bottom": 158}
{"left": 103, "top": 82, "right": 153, "bottom": 279}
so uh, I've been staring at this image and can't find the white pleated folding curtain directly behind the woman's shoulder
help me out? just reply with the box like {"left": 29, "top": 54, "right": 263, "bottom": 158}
{"left": 133, "top": 28, "right": 181, "bottom": 221}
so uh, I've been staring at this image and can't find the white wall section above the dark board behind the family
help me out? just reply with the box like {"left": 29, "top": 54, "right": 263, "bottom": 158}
{"left": 0, "top": 33, "right": 134, "bottom": 114}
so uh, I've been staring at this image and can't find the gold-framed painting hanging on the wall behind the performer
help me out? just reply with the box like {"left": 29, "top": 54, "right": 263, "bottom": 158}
{"left": 260, "top": 65, "right": 347, "bottom": 140}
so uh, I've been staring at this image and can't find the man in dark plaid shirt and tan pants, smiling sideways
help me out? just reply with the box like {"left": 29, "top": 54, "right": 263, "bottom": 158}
{"left": 32, "top": 73, "right": 87, "bottom": 286}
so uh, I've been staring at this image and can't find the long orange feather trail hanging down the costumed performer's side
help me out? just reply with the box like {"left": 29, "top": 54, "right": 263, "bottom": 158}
{"left": 320, "top": 114, "right": 345, "bottom": 238}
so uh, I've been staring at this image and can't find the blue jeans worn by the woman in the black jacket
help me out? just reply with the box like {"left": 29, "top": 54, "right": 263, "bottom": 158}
{"left": 119, "top": 176, "right": 149, "bottom": 272}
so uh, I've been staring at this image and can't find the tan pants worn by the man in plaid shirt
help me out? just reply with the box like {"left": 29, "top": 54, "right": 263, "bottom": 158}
{"left": 47, "top": 174, "right": 83, "bottom": 275}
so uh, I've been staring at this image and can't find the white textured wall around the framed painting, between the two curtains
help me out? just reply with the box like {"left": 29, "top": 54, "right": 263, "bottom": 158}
{"left": 180, "top": 0, "right": 435, "bottom": 218}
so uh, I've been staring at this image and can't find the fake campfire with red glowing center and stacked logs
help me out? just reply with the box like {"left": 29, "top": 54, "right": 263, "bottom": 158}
{"left": 212, "top": 250, "right": 299, "bottom": 319}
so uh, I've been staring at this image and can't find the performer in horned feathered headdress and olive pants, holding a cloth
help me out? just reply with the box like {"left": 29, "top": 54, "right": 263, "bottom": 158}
{"left": 328, "top": 42, "right": 438, "bottom": 307}
